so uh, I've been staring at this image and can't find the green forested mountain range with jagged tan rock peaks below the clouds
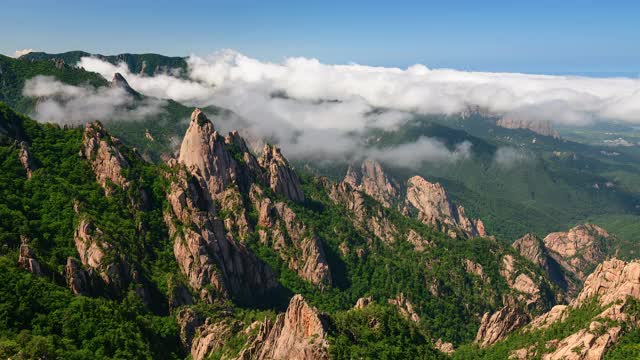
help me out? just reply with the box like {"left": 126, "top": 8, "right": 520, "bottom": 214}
{"left": 0, "top": 52, "right": 640, "bottom": 359}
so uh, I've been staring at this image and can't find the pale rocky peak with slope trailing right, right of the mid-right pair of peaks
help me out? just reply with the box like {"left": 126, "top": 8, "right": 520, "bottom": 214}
{"left": 405, "top": 176, "right": 486, "bottom": 237}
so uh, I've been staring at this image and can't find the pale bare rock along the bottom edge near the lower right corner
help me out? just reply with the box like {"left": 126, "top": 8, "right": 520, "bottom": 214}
{"left": 542, "top": 322, "right": 622, "bottom": 360}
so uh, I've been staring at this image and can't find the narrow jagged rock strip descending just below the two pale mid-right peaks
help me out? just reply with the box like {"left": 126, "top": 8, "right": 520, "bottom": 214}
{"left": 324, "top": 180, "right": 398, "bottom": 243}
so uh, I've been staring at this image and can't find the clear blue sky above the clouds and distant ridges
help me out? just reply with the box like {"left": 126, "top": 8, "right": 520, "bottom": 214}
{"left": 0, "top": 0, "right": 640, "bottom": 76}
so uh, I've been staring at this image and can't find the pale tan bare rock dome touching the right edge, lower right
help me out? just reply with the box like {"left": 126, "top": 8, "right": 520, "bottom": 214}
{"left": 571, "top": 259, "right": 640, "bottom": 306}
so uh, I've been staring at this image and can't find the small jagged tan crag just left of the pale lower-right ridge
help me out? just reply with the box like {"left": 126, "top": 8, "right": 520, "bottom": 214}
{"left": 475, "top": 299, "right": 529, "bottom": 347}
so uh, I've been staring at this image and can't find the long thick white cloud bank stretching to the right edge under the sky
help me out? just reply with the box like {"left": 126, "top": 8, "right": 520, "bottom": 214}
{"left": 26, "top": 50, "right": 640, "bottom": 165}
